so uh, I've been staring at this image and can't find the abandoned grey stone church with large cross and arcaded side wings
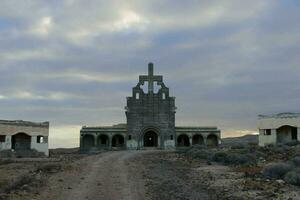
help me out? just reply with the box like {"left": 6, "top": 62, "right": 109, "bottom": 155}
{"left": 80, "top": 63, "right": 221, "bottom": 151}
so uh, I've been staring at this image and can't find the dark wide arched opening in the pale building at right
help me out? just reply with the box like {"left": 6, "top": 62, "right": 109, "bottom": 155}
{"left": 276, "top": 125, "right": 298, "bottom": 143}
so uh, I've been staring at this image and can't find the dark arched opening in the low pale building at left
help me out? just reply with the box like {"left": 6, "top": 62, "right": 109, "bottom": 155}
{"left": 11, "top": 133, "right": 31, "bottom": 150}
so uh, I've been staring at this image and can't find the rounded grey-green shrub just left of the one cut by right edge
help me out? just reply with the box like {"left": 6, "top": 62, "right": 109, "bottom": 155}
{"left": 263, "top": 163, "right": 292, "bottom": 179}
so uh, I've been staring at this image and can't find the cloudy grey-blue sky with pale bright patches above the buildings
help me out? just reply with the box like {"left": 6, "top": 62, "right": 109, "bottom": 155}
{"left": 0, "top": 0, "right": 300, "bottom": 148}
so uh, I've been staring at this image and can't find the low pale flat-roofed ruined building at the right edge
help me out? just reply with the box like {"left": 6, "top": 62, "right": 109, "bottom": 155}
{"left": 258, "top": 113, "right": 300, "bottom": 146}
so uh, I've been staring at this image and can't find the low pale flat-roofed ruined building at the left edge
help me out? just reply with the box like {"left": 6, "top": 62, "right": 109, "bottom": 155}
{"left": 0, "top": 120, "right": 49, "bottom": 156}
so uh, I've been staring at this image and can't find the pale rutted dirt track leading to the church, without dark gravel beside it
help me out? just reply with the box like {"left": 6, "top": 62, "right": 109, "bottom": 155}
{"left": 39, "top": 151, "right": 146, "bottom": 200}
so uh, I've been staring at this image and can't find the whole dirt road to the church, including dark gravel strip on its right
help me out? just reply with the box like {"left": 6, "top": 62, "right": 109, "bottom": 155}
{"left": 36, "top": 150, "right": 211, "bottom": 200}
